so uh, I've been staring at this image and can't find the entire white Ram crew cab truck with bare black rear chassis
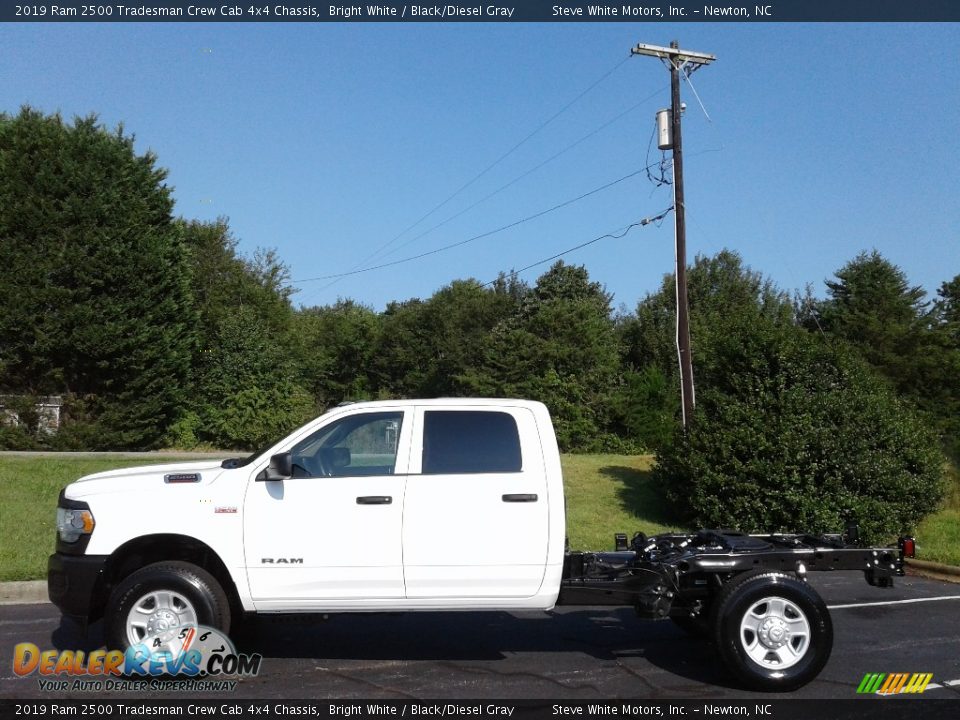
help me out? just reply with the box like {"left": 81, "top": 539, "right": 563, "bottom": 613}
{"left": 48, "top": 399, "right": 912, "bottom": 690}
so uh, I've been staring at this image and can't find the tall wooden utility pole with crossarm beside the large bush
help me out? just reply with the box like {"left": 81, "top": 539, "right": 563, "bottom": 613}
{"left": 630, "top": 40, "right": 716, "bottom": 429}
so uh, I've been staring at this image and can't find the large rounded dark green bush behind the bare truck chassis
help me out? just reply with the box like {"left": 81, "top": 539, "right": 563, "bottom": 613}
{"left": 655, "top": 324, "right": 944, "bottom": 543}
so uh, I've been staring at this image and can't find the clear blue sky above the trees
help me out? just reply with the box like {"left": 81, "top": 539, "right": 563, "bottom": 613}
{"left": 0, "top": 23, "right": 960, "bottom": 309}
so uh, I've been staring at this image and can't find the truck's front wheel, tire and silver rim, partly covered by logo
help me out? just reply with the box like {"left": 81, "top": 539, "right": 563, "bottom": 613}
{"left": 104, "top": 561, "right": 230, "bottom": 655}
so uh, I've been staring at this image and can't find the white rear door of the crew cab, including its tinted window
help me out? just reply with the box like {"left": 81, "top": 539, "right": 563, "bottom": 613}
{"left": 403, "top": 405, "right": 549, "bottom": 598}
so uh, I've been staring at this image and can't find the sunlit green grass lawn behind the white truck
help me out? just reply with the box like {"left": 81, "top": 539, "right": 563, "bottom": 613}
{"left": 0, "top": 455, "right": 960, "bottom": 581}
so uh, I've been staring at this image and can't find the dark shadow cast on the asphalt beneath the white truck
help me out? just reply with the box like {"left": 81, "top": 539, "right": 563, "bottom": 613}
{"left": 51, "top": 607, "right": 737, "bottom": 697}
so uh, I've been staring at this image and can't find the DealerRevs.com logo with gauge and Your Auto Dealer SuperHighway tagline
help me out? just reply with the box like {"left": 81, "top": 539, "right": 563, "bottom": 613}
{"left": 13, "top": 625, "right": 263, "bottom": 692}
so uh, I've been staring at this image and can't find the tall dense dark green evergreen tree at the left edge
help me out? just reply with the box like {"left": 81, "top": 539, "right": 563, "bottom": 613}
{"left": 0, "top": 108, "right": 194, "bottom": 448}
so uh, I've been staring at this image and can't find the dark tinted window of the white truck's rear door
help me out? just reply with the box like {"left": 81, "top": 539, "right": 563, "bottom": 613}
{"left": 422, "top": 410, "right": 523, "bottom": 475}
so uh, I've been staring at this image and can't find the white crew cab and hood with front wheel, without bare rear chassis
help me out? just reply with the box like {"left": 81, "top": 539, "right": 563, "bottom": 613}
{"left": 48, "top": 399, "right": 565, "bottom": 649}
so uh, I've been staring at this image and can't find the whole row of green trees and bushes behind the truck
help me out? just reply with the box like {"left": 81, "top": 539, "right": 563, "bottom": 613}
{"left": 0, "top": 108, "right": 960, "bottom": 540}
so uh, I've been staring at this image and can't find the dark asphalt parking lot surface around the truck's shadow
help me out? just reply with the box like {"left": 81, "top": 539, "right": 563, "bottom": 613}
{"left": 0, "top": 573, "right": 960, "bottom": 700}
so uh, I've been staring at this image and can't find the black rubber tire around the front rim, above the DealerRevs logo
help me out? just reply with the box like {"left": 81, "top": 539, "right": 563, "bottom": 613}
{"left": 104, "top": 560, "right": 230, "bottom": 650}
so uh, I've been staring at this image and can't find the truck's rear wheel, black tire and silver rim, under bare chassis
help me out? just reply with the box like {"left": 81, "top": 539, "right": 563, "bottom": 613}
{"left": 712, "top": 572, "right": 833, "bottom": 692}
